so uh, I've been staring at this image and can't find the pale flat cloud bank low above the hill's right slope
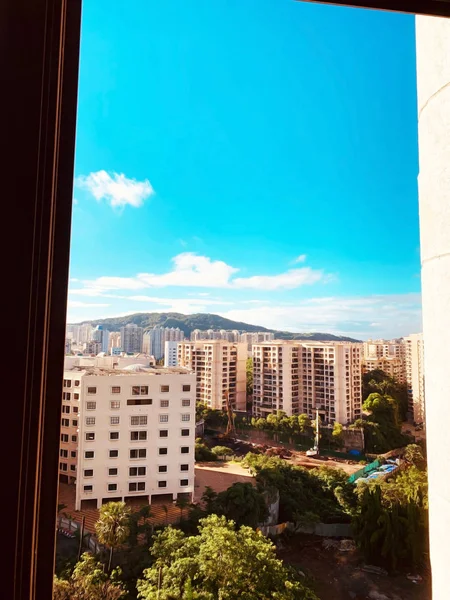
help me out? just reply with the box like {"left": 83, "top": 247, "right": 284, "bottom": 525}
{"left": 219, "top": 294, "right": 422, "bottom": 339}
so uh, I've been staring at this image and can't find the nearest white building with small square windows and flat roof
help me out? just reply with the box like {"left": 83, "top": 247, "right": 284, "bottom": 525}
{"left": 59, "top": 364, "right": 195, "bottom": 510}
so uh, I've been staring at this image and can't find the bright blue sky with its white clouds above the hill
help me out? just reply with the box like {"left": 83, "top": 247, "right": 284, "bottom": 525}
{"left": 68, "top": 0, "right": 421, "bottom": 338}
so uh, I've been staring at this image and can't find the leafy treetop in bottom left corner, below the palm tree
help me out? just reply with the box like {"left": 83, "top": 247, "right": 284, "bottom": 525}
{"left": 53, "top": 553, "right": 125, "bottom": 600}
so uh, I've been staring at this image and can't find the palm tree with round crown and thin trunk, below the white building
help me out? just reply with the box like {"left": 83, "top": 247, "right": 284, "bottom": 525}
{"left": 95, "top": 502, "right": 131, "bottom": 572}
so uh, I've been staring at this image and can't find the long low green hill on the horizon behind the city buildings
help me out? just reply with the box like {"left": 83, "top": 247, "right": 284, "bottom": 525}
{"left": 67, "top": 313, "right": 360, "bottom": 342}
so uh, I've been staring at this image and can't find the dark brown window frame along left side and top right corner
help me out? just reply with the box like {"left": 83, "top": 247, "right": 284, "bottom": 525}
{"left": 8, "top": 0, "right": 450, "bottom": 600}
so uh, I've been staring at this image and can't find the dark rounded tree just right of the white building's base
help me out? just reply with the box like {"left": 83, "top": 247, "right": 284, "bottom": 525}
{"left": 209, "top": 483, "right": 268, "bottom": 527}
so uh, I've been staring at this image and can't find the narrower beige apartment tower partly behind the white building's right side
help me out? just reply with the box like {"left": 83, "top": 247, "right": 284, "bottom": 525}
{"left": 178, "top": 340, "right": 247, "bottom": 410}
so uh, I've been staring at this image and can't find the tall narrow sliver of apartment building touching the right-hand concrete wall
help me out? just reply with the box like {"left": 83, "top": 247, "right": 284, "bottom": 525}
{"left": 404, "top": 333, "right": 425, "bottom": 423}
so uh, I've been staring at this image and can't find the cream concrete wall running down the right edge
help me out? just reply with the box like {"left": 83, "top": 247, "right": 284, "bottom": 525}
{"left": 416, "top": 17, "right": 450, "bottom": 600}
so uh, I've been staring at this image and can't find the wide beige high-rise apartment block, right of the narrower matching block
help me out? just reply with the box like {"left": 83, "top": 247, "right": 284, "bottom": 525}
{"left": 253, "top": 340, "right": 362, "bottom": 425}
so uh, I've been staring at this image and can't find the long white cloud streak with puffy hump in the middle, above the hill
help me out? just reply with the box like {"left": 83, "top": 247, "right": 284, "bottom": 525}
{"left": 72, "top": 252, "right": 327, "bottom": 295}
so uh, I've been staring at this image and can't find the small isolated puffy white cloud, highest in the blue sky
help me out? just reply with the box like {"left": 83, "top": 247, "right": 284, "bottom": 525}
{"left": 75, "top": 171, "right": 155, "bottom": 208}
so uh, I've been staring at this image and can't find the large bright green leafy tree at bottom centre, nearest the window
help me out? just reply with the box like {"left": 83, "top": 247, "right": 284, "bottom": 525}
{"left": 137, "top": 515, "right": 317, "bottom": 600}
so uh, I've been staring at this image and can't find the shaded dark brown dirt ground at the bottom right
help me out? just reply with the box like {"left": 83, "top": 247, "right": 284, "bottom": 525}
{"left": 278, "top": 535, "right": 431, "bottom": 600}
